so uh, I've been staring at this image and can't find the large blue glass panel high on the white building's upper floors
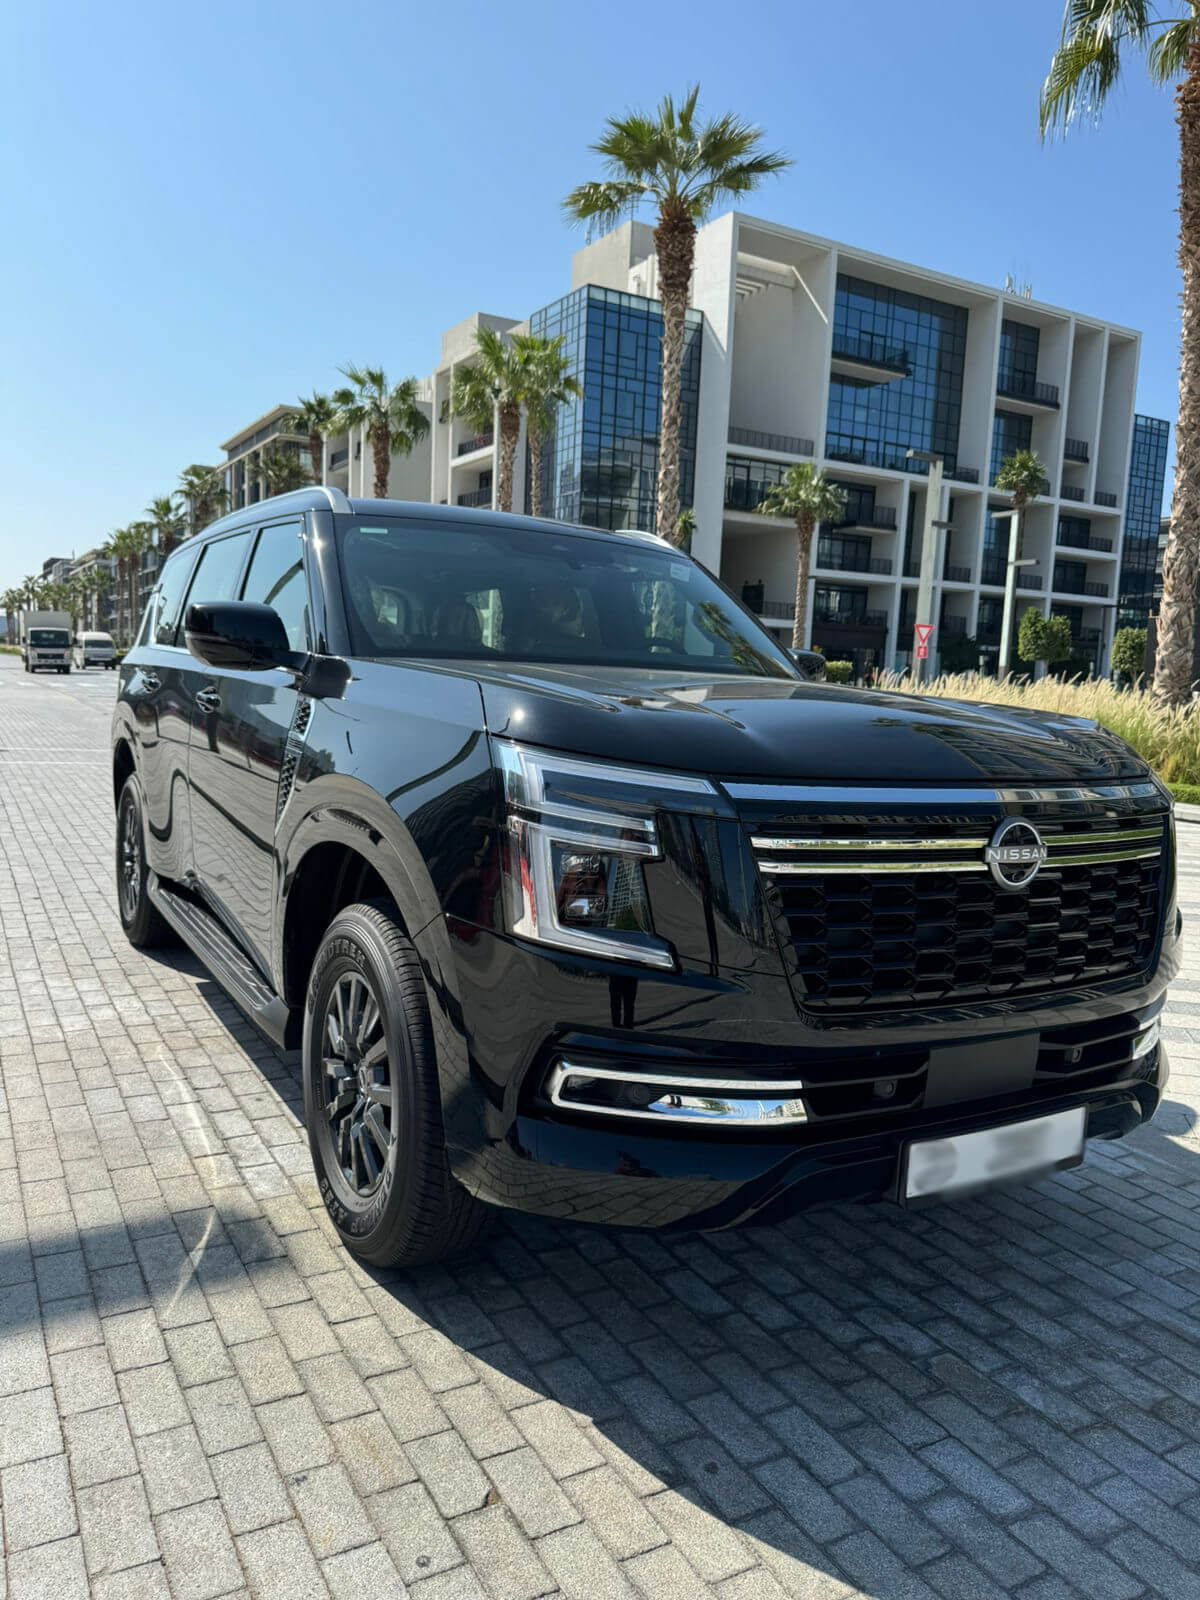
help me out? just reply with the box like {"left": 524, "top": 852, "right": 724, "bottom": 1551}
{"left": 826, "top": 274, "right": 966, "bottom": 474}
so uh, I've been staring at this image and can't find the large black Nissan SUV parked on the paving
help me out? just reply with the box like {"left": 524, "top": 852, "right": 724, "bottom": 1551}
{"left": 112, "top": 490, "right": 1179, "bottom": 1262}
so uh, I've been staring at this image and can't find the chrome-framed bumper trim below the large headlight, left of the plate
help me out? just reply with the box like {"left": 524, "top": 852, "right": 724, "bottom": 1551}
{"left": 546, "top": 1061, "right": 808, "bottom": 1128}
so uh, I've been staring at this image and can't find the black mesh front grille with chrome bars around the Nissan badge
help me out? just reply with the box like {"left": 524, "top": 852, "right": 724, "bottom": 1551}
{"left": 752, "top": 811, "right": 1166, "bottom": 1011}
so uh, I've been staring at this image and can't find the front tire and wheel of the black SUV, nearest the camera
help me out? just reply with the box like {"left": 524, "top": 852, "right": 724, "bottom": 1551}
{"left": 304, "top": 904, "right": 491, "bottom": 1267}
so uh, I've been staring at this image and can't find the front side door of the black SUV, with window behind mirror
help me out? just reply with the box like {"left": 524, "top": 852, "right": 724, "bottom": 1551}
{"left": 187, "top": 518, "right": 312, "bottom": 970}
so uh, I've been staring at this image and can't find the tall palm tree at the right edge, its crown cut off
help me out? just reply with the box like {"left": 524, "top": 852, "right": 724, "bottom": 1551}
{"left": 1038, "top": 0, "right": 1200, "bottom": 706}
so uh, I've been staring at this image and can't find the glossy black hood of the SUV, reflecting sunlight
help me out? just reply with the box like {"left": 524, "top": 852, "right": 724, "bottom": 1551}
{"left": 444, "top": 662, "right": 1147, "bottom": 784}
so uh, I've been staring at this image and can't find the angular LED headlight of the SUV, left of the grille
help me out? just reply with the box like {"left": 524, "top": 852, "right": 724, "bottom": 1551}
{"left": 493, "top": 739, "right": 723, "bottom": 968}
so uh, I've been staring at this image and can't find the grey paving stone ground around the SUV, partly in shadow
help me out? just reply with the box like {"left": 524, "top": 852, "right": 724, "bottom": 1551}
{"left": 0, "top": 658, "right": 1200, "bottom": 1600}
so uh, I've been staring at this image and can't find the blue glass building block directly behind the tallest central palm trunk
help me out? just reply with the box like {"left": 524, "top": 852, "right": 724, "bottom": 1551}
{"left": 526, "top": 285, "right": 702, "bottom": 531}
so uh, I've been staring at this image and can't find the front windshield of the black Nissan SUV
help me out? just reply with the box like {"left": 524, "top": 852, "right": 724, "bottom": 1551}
{"left": 339, "top": 517, "right": 795, "bottom": 678}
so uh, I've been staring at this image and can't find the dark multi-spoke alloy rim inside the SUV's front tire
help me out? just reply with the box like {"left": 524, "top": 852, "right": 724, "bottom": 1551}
{"left": 322, "top": 973, "right": 395, "bottom": 1197}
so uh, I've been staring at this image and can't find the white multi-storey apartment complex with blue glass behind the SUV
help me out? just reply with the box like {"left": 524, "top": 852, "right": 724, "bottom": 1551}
{"left": 224, "top": 213, "right": 1168, "bottom": 672}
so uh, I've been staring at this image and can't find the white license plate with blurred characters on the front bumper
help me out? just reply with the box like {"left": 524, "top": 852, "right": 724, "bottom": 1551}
{"left": 904, "top": 1106, "right": 1088, "bottom": 1200}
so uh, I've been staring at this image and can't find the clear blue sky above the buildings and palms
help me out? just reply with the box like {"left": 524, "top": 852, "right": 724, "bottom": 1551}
{"left": 0, "top": 0, "right": 1178, "bottom": 587}
